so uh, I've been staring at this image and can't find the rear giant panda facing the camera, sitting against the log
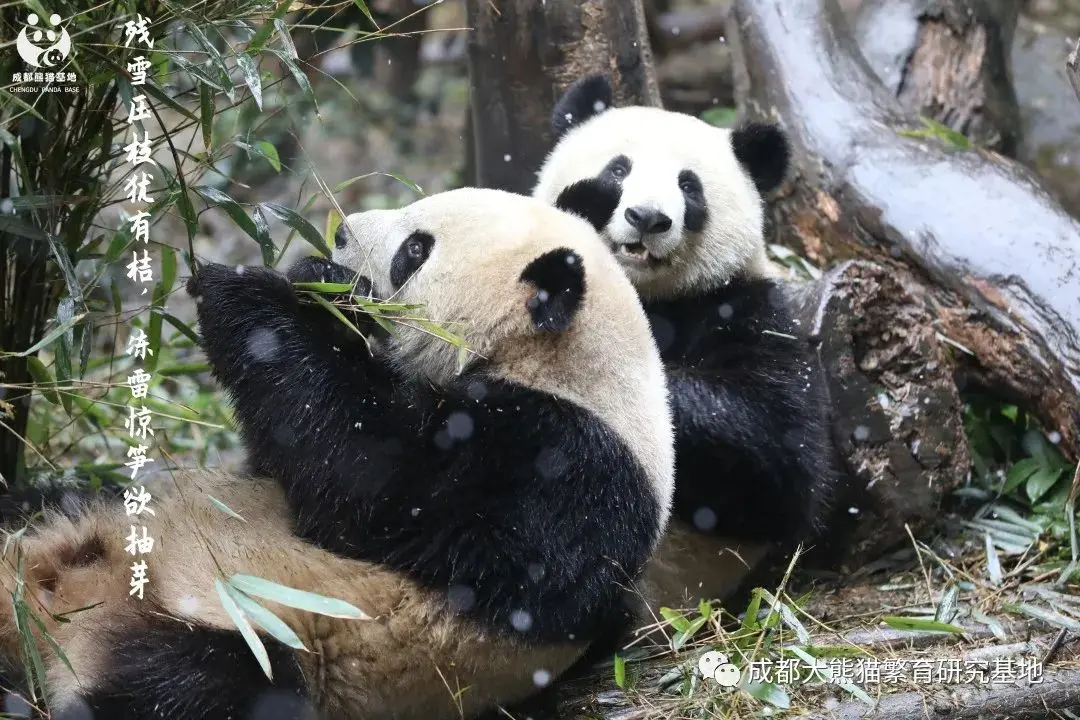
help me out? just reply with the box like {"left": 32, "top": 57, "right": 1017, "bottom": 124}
{"left": 534, "top": 76, "right": 836, "bottom": 617}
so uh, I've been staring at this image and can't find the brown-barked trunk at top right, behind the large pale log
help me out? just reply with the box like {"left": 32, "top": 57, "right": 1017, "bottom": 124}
{"left": 854, "top": 0, "right": 1021, "bottom": 157}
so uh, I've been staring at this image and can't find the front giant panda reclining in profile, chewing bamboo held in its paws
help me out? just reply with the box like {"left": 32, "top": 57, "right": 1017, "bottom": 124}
{"left": 0, "top": 190, "right": 674, "bottom": 720}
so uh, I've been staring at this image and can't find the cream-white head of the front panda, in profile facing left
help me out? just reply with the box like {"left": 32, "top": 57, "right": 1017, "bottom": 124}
{"left": 333, "top": 188, "right": 639, "bottom": 383}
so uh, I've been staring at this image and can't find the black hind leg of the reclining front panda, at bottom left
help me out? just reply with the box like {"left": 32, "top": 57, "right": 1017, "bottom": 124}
{"left": 52, "top": 616, "right": 319, "bottom": 720}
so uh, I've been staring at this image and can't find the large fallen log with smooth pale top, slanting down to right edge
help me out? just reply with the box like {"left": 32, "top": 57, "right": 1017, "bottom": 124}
{"left": 729, "top": 0, "right": 1080, "bottom": 458}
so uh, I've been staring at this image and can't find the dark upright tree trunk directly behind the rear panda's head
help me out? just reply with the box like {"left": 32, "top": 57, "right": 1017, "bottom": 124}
{"left": 465, "top": 0, "right": 660, "bottom": 193}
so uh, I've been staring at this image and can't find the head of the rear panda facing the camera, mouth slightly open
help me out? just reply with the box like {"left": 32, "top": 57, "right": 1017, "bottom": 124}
{"left": 534, "top": 76, "right": 791, "bottom": 299}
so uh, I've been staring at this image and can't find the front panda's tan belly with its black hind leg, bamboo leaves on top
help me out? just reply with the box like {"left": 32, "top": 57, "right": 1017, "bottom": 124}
{"left": 0, "top": 472, "right": 583, "bottom": 720}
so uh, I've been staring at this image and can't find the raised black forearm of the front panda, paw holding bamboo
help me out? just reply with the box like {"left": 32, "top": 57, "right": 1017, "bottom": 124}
{"left": 189, "top": 264, "right": 419, "bottom": 504}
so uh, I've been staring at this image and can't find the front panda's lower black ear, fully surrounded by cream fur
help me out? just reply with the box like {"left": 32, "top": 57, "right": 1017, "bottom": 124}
{"left": 521, "top": 247, "right": 585, "bottom": 332}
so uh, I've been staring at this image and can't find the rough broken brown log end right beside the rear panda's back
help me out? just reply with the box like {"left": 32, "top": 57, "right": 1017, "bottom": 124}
{"left": 786, "top": 261, "right": 971, "bottom": 572}
